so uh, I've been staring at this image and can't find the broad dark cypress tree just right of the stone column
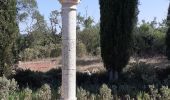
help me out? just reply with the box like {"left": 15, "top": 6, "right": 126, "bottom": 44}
{"left": 99, "top": 0, "right": 138, "bottom": 81}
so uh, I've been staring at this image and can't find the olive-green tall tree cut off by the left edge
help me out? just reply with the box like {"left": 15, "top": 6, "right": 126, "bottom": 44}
{"left": 0, "top": 0, "right": 18, "bottom": 76}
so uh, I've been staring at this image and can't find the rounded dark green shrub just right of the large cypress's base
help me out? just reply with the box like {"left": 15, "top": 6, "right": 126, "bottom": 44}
{"left": 124, "top": 62, "right": 159, "bottom": 85}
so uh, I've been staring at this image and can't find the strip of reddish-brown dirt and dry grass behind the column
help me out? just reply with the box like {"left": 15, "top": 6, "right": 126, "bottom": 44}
{"left": 18, "top": 56, "right": 170, "bottom": 73}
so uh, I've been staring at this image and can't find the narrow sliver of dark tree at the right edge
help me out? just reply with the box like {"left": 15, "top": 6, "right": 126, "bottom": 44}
{"left": 166, "top": 5, "right": 170, "bottom": 60}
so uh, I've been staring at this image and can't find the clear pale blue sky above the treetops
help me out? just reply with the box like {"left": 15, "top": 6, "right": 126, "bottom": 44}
{"left": 37, "top": 0, "right": 169, "bottom": 23}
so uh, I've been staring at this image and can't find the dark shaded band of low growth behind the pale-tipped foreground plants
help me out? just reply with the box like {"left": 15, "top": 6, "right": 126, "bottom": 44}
{"left": 13, "top": 59, "right": 170, "bottom": 96}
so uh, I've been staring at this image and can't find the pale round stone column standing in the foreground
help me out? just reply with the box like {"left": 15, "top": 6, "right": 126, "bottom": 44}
{"left": 59, "top": 0, "right": 79, "bottom": 100}
